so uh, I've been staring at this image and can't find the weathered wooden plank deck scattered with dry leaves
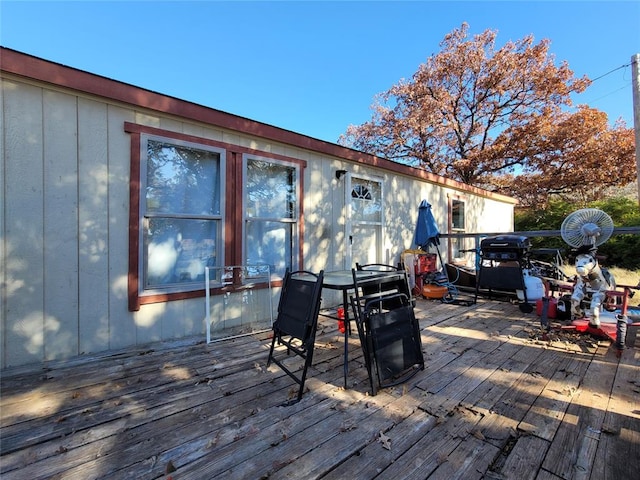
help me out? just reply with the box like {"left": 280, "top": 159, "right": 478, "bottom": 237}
{"left": 0, "top": 300, "right": 640, "bottom": 480}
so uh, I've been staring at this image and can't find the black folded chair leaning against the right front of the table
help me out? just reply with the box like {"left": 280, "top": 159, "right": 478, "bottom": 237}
{"left": 351, "top": 270, "right": 424, "bottom": 395}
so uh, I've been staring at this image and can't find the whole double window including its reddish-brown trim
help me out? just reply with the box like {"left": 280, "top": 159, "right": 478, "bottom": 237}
{"left": 124, "top": 122, "right": 306, "bottom": 311}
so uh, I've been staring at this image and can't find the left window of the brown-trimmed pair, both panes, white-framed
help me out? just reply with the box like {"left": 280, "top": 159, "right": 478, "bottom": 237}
{"left": 139, "top": 135, "right": 224, "bottom": 295}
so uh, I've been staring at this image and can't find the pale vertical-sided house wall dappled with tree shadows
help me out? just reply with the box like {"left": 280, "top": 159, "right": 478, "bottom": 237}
{"left": 0, "top": 50, "right": 513, "bottom": 369}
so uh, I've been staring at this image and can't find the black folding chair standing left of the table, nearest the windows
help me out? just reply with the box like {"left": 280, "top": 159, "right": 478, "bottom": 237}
{"left": 267, "top": 270, "right": 324, "bottom": 404}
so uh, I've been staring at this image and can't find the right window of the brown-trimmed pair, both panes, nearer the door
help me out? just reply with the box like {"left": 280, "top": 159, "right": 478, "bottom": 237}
{"left": 243, "top": 156, "right": 300, "bottom": 276}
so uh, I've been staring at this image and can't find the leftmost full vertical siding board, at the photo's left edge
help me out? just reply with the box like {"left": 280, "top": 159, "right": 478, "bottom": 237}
{"left": 2, "top": 82, "right": 44, "bottom": 367}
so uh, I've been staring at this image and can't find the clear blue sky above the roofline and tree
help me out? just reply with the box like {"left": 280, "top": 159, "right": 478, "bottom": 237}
{"left": 0, "top": 0, "right": 640, "bottom": 142}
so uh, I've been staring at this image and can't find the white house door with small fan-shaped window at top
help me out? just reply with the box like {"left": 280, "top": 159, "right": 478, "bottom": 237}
{"left": 345, "top": 174, "right": 384, "bottom": 266}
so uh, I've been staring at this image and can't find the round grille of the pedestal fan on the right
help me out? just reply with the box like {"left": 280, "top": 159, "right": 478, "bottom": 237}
{"left": 560, "top": 208, "right": 613, "bottom": 248}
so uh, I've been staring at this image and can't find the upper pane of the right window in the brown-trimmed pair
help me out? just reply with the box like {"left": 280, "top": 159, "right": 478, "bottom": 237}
{"left": 246, "top": 160, "right": 297, "bottom": 218}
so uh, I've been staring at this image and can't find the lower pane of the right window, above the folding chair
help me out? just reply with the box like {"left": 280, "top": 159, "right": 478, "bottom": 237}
{"left": 245, "top": 220, "right": 294, "bottom": 275}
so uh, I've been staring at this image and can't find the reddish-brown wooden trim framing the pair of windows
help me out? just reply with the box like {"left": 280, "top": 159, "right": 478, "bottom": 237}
{"left": 124, "top": 122, "right": 307, "bottom": 312}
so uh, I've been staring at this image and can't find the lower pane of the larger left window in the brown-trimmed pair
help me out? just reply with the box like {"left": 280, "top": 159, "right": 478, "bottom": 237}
{"left": 144, "top": 217, "right": 220, "bottom": 288}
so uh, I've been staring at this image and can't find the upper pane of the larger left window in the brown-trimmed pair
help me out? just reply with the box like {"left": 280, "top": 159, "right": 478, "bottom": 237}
{"left": 146, "top": 140, "right": 220, "bottom": 215}
